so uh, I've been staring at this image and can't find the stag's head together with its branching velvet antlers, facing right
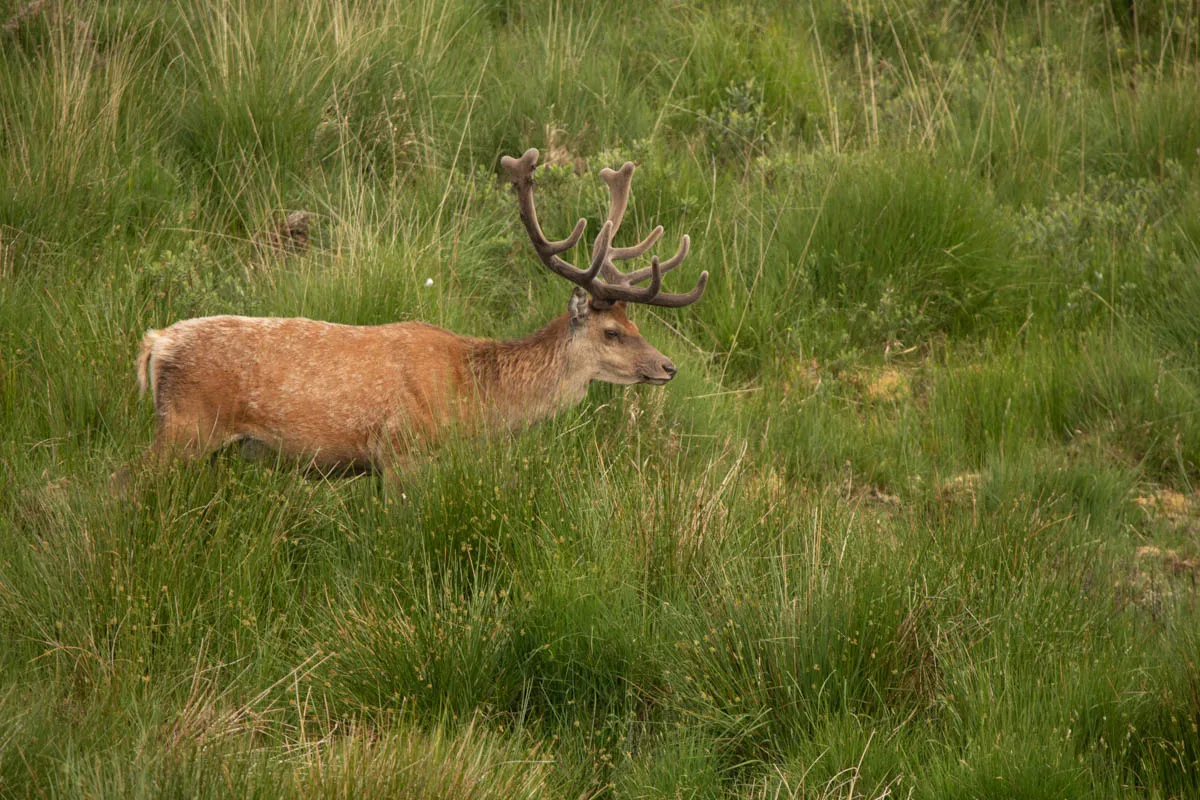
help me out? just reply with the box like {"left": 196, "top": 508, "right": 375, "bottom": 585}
{"left": 500, "top": 148, "right": 708, "bottom": 384}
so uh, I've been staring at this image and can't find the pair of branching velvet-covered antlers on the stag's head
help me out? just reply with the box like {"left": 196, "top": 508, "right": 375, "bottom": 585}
{"left": 500, "top": 148, "right": 708, "bottom": 308}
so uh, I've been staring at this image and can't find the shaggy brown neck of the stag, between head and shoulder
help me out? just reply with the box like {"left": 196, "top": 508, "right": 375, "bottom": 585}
{"left": 467, "top": 314, "right": 590, "bottom": 426}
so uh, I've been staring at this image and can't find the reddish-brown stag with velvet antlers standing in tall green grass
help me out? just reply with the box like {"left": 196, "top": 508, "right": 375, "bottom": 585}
{"left": 130, "top": 149, "right": 708, "bottom": 479}
